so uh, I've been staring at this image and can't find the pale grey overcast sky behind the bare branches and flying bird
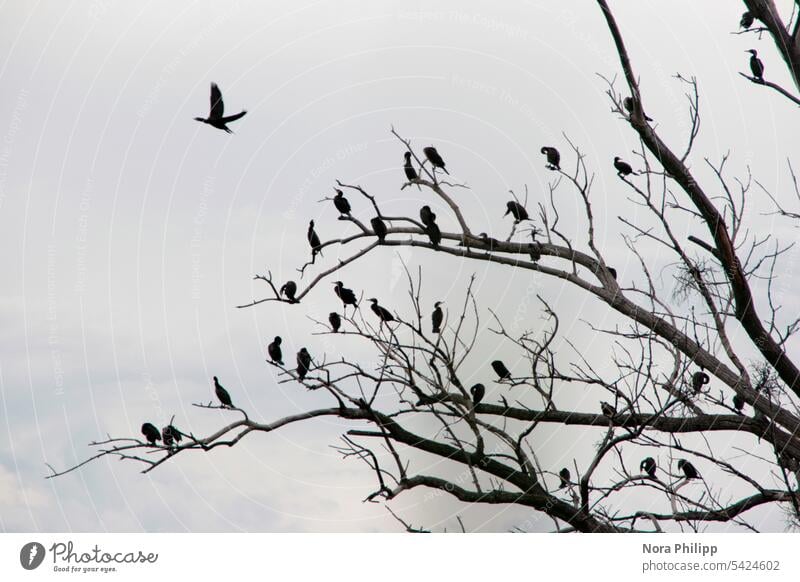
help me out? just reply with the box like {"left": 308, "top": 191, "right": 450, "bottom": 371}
{"left": 0, "top": 0, "right": 798, "bottom": 531}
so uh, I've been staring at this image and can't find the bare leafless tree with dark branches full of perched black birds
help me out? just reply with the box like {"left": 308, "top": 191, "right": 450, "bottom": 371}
{"left": 51, "top": 0, "right": 800, "bottom": 532}
